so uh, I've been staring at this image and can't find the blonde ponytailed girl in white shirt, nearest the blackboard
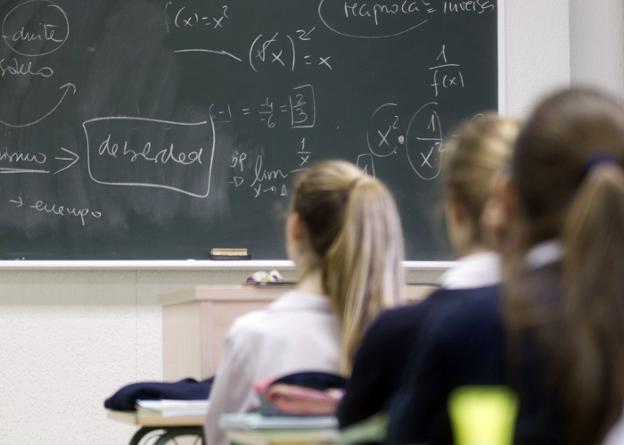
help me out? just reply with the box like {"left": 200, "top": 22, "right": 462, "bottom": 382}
{"left": 205, "top": 161, "right": 404, "bottom": 445}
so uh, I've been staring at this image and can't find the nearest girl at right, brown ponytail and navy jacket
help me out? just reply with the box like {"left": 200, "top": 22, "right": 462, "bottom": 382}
{"left": 388, "top": 90, "right": 624, "bottom": 445}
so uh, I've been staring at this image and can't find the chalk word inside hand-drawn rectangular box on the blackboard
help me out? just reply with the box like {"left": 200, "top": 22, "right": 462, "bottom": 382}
{"left": 83, "top": 116, "right": 215, "bottom": 198}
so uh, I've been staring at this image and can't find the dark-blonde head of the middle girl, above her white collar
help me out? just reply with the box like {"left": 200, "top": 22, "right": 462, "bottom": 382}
{"left": 443, "top": 114, "right": 520, "bottom": 255}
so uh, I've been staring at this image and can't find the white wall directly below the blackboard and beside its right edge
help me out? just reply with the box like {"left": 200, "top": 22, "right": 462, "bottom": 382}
{"left": 0, "top": 0, "right": 576, "bottom": 445}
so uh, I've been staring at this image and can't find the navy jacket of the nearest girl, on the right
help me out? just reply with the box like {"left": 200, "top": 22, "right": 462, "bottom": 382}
{"left": 387, "top": 272, "right": 565, "bottom": 445}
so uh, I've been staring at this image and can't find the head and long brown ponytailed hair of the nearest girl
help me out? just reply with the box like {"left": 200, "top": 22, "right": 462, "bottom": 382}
{"left": 505, "top": 89, "right": 624, "bottom": 445}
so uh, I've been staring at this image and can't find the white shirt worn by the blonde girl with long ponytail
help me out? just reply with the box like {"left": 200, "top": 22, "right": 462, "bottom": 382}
{"left": 204, "top": 291, "right": 340, "bottom": 445}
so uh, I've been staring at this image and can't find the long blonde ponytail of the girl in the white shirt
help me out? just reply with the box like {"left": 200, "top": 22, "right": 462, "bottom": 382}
{"left": 323, "top": 176, "right": 404, "bottom": 374}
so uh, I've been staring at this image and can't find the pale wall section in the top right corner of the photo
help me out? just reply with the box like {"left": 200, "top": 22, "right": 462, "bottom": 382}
{"left": 570, "top": 0, "right": 624, "bottom": 97}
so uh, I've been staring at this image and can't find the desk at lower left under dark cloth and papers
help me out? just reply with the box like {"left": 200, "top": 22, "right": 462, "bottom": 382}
{"left": 107, "top": 410, "right": 204, "bottom": 445}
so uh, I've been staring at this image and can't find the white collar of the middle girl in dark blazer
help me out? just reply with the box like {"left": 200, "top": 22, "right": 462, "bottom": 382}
{"left": 440, "top": 252, "right": 501, "bottom": 289}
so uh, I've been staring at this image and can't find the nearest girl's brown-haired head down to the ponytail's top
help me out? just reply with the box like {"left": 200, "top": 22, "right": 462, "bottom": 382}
{"left": 512, "top": 89, "right": 624, "bottom": 245}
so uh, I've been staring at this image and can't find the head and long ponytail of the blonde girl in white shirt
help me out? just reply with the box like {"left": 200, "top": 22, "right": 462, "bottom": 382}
{"left": 287, "top": 161, "right": 404, "bottom": 372}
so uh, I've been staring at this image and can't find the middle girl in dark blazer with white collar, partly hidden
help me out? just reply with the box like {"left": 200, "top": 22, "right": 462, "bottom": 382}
{"left": 338, "top": 114, "right": 519, "bottom": 428}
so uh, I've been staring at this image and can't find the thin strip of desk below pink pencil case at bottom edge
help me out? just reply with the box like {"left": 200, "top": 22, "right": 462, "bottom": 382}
{"left": 227, "top": 430, "right": 340, "bottom": 445}
